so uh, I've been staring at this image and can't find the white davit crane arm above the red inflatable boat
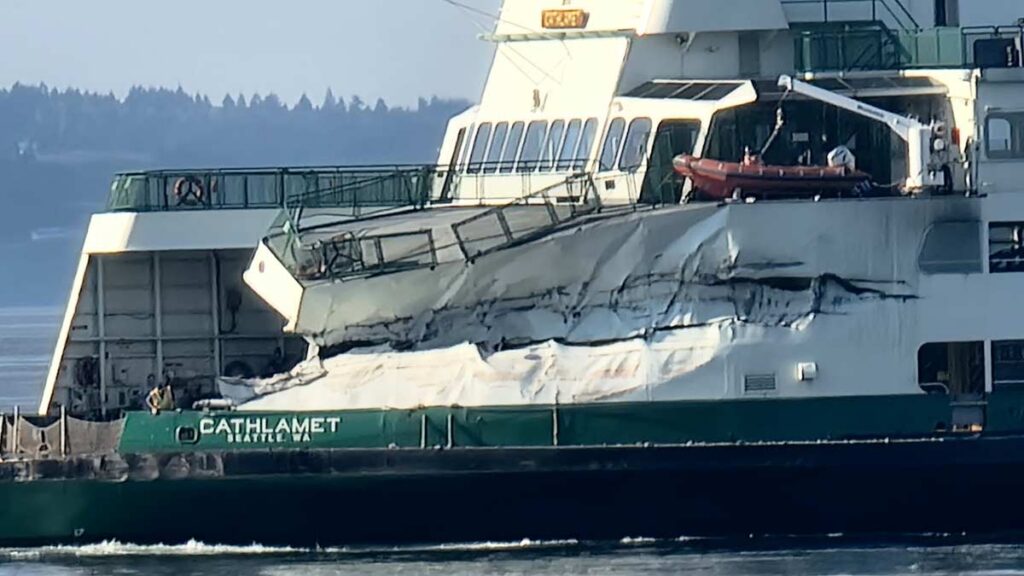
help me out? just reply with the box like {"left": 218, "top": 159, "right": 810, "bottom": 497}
{"left": 778, "top": 76, "right": 952, "bottom": 192}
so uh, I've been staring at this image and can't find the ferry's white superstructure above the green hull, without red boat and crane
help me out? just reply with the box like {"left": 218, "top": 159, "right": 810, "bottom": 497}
{"left": 41, "top": 0, "right": 1024, "bottom": 422}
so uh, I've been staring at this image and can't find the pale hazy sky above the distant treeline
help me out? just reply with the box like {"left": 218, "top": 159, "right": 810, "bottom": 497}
{"left": 0, "top": 0, "right": 499, "bottom": 105}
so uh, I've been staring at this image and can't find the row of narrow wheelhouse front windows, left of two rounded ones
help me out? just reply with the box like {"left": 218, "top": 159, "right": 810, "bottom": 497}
{"left": 458, "top": 118, "right": 597, "bottom": 174}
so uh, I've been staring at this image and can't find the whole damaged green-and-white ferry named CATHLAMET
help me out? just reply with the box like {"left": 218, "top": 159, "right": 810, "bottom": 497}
{"left": 6, "top": 0, "right": 1024, "bottom": 546}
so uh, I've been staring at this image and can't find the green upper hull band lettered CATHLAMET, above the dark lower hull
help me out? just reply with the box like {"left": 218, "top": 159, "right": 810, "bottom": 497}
{"left": 120, "top": 395, "right": 974, "bottom": 453}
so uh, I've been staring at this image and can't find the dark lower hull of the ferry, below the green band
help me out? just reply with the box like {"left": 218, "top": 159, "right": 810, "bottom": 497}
{"left": 6, "top": 437, "right": 1024, "bottom": 546}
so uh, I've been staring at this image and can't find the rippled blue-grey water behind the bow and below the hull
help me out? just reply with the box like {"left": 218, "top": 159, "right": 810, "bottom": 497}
{"left": 0, "top": 307, "right": 1024, "bottom": 576}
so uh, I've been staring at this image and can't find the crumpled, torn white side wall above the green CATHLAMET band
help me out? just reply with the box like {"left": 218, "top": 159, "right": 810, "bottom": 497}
{"left": 235, "top": 197, "right": 982, "bottom": 410}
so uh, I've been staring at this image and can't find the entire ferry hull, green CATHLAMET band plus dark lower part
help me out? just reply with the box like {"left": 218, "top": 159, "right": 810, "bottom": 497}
{"left": 0, "top": 393, "right": 1024, "bottom": 546}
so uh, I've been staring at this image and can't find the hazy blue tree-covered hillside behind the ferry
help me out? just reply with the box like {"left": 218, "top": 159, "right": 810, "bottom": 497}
{"left": 0, "top": 85, "right": 469, "bottom": 307}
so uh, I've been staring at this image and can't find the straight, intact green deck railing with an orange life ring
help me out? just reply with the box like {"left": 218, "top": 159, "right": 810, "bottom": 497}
{"left": 108, "top": 165, "right": 456, "bottom": 217}
